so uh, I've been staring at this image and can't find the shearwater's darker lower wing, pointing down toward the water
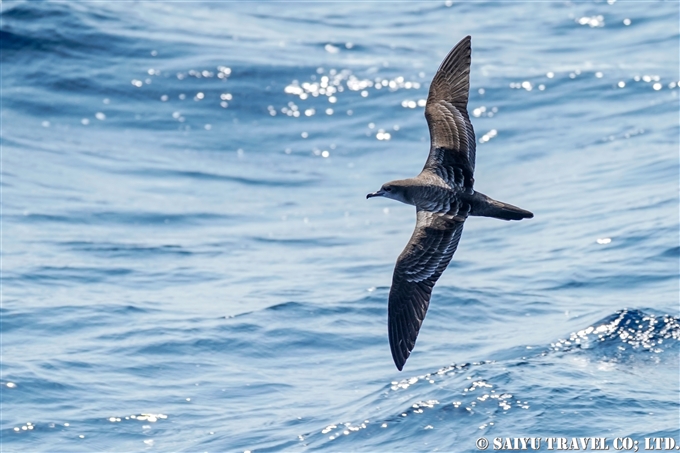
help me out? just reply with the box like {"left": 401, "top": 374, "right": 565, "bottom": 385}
{"left": 388, "top": 211, "right": 463, "bottom": 371}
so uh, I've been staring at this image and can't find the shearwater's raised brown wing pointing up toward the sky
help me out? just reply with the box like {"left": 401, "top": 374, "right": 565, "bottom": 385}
{"left": 425, "top": 36, "right": 476, "bottom": 188}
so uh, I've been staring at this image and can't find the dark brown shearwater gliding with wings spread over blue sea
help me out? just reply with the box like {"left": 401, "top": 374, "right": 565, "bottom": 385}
{"left": 366, "top": 36, "right": 534, "bottom": 371}
